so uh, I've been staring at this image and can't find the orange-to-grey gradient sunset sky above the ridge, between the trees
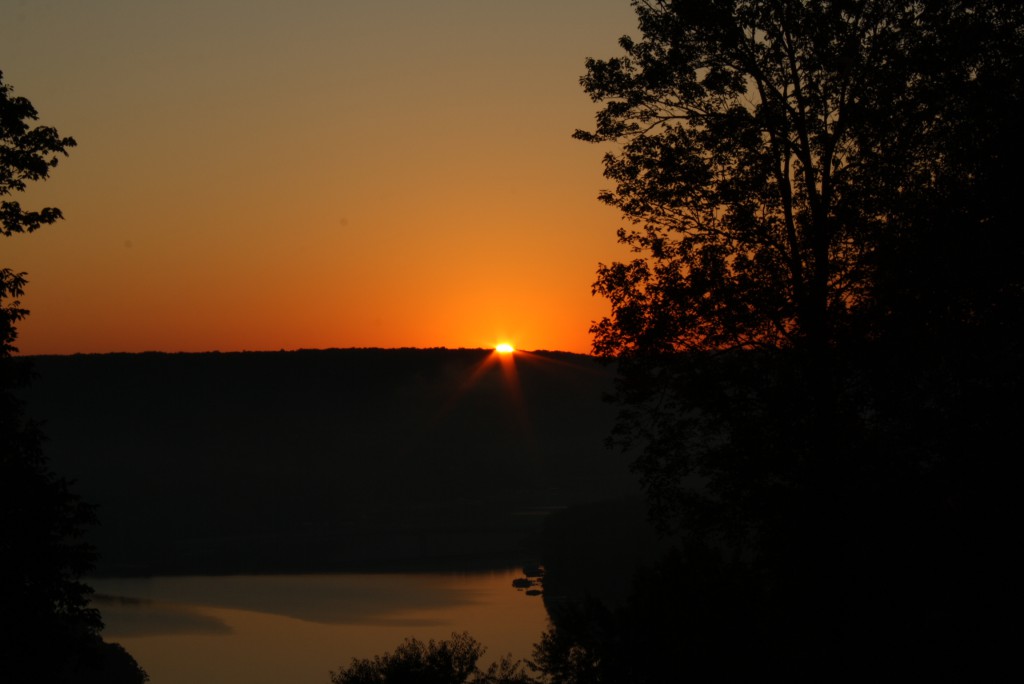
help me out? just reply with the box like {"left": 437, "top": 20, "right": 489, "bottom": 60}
{"left": 0, "top": 0, "right": 636, "bottom": 353}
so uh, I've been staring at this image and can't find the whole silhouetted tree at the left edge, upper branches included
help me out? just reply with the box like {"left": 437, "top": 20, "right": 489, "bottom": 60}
{"left": 0, "top": 73, "right": 147, "bottom": 684}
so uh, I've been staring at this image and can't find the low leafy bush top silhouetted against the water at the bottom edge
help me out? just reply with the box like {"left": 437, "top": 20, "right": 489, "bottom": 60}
{"left": 331, "top": 632, "right": 535, "bottom": 684}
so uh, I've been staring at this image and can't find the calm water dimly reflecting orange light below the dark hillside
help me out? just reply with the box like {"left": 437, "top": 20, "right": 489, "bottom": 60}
{"left": 89, "top": 570, "right": 547, "bottom": 684}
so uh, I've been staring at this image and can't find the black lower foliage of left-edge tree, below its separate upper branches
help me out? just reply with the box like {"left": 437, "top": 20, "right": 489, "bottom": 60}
{"left": 0, "top": 290, "right": 147, "bottom": 684}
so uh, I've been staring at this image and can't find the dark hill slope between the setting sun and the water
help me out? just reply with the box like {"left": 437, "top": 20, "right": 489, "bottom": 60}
{"left": 27, "top": 349, "right": 634, "bottom": 573}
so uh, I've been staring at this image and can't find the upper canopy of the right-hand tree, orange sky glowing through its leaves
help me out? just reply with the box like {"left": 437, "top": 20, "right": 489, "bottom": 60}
{"left": 577, "top": 0, "right": 1021, "bottom": 354}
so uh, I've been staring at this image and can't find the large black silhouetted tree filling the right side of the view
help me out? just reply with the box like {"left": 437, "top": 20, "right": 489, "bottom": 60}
{"left": 575, "top": 0, "right": 1024, "bottom": 668}
